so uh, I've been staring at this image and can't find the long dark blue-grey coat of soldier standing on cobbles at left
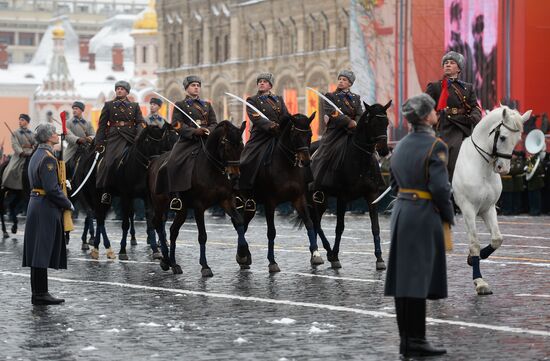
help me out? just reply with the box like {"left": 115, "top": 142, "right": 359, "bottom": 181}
{"left": 23, "top": 144, "right": 71, "bottom": 269}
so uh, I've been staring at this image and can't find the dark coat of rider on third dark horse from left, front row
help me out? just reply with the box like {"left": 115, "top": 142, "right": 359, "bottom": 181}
{"left": 239, "top": 94, "right": 288, "bottom": 190}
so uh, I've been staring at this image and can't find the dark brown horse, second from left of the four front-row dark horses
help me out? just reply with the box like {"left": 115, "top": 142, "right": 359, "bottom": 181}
{"left": 148, "top": 121, "right": 252, "bottom": 277}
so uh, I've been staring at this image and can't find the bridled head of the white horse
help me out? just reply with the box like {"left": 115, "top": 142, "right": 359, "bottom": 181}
{"left": 488, "top": 105, "right": 531, "bottom": 174}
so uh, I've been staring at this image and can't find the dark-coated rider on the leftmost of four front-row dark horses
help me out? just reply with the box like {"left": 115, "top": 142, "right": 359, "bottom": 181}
{"left": 96, "top": 80, "right": 143, "bottom": 204}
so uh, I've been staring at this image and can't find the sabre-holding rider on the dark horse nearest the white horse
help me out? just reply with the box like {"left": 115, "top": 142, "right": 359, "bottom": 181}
{"left": 311, "top": 70, "right": 363, "bottom": 203}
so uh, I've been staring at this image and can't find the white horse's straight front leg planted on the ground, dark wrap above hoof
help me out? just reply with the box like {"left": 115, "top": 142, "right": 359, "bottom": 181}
{"left": 460, "top": 204, "right": 492, "bottom": 295}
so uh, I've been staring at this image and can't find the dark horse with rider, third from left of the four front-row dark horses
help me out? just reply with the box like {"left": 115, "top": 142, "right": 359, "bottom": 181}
{"left": 240, "top": 113, "right": 323, "bottom": 272}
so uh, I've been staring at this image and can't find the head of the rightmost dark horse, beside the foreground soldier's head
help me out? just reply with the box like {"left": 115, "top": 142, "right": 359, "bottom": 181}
{"left": 356, "top": 100, "right": 392, "bottom": 157}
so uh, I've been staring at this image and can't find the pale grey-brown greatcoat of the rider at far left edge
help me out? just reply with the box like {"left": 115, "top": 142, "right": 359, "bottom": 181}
{"left": 2, "top": 128, "right": 36, "bottom": 190}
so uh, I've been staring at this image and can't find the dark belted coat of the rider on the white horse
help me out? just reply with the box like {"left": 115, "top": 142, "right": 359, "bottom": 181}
{"left": 426, "top": 80, "right": 481, "bottom": 179}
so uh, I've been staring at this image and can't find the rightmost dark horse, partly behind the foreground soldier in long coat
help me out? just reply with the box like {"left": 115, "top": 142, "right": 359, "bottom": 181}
{"left": 310, "top": 100, "right": 391, "bottom": 270}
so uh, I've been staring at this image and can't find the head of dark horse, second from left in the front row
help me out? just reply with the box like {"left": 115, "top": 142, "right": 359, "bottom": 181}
{"left": 208, "top": 120, "right": 246, "bottom": 177}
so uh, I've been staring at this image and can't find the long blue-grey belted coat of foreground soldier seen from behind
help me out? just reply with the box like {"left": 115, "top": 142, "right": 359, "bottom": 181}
{"left": 385, "top": 127, "right": 454, "bottom": 299}
